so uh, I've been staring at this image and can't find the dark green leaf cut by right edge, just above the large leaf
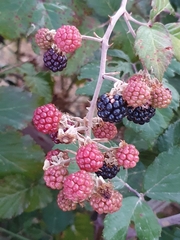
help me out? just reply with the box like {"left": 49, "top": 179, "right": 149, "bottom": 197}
{"left": 157, "top": 120, "right": 180, "bottom": 152}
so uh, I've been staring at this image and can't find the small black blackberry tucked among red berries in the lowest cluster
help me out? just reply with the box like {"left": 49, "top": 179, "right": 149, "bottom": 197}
{"left": 95, "top": 162, "right": 120, "bottom": 179}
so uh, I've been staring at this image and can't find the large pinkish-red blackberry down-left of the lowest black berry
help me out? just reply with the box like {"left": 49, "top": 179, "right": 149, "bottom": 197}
{"left": 63, "top": 170, "right": 94, "bottom": 203}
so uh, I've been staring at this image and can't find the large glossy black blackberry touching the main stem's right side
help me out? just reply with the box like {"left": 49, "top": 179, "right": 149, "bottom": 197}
{"left": 97, "top": 93, "right": 127, "bottom": 123}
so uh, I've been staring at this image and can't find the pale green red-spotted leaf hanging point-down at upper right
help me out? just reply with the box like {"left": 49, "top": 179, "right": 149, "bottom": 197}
{"left": 135, "top": 23, "right": 173, "bottom": 81}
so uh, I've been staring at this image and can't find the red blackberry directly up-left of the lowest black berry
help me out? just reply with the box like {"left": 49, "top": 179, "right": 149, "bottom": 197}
{"left": 76, "top": 143, "right": 104, "bottom": 172}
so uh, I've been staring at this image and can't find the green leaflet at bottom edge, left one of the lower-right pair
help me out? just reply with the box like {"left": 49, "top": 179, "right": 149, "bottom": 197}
{"left": 103, "top": 197, "right": 139, "bottom": 240}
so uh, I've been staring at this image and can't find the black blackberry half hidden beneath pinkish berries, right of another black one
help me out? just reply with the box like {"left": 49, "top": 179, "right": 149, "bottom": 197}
{"left": 127, "top": 105, "right": 156, "bottom": 125}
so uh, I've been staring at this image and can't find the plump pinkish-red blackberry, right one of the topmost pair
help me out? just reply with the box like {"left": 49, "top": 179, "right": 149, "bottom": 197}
{"left": 54, "top": 25, "right": 82, "bottom": 53}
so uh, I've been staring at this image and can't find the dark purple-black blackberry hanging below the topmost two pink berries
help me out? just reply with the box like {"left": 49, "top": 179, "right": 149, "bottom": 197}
{"left": 43, "top": 48, "right": 67, "bottom": 72}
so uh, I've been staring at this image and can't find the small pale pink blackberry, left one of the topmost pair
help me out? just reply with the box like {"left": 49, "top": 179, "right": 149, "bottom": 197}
{"left": 35, "top": 28, "right": 56, "bottom": 50}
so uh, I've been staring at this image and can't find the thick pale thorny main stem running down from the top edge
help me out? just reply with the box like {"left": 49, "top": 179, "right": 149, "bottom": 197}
{"left": 86, "top": 0, "right": 127, "bottom": 136}
